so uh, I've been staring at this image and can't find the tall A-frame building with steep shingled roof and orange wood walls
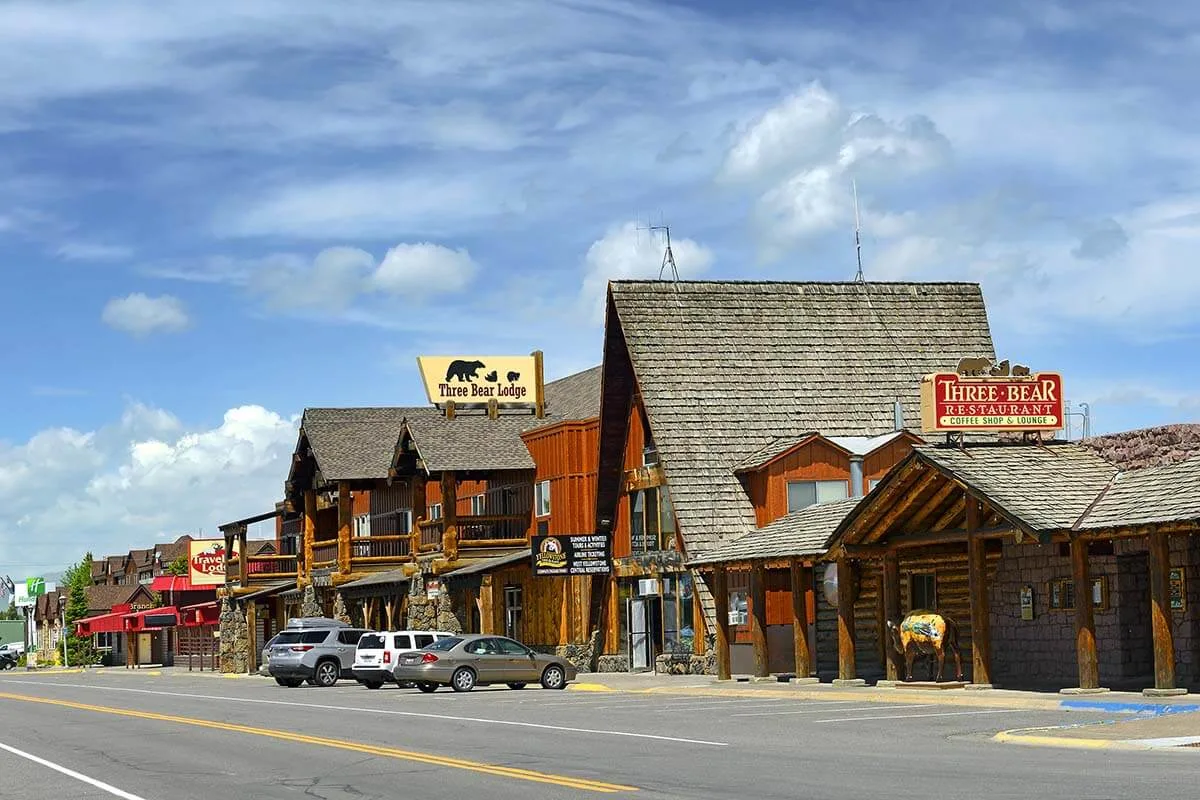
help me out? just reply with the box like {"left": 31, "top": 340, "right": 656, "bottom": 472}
{"left": 595, "top": 281, "right": 992, "bottom": 673}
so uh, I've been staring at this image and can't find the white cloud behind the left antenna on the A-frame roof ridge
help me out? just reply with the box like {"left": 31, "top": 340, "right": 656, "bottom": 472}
{"left": 581, "top": 222, "right": 714, "bottom": 321}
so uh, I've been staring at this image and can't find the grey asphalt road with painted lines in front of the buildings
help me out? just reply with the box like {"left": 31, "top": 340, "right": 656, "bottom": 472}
{"left": 0, "top": 673, "right": 1200, "bottom": 800}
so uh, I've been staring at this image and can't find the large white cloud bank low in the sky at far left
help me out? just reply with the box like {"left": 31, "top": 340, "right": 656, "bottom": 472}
{"left": 0, "top": 403, "right": 299, "bottom": 572}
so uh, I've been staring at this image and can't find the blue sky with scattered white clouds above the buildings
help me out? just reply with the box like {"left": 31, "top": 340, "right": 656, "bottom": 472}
{"left": 0, "top": 0, "right": 1200, "bottom": 577}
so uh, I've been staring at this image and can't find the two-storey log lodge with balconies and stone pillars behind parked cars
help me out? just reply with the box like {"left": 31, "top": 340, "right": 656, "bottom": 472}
{"left": 221, "top": 362, "right": 600, "bottom": 672}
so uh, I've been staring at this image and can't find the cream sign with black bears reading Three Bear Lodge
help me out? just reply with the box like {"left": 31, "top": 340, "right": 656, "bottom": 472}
{"left": 416, "top": 355, "right": 538, "bottom": 405}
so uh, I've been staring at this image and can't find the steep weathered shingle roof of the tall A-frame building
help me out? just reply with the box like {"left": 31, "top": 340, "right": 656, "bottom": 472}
{"left": 608, "top": 281, "right": 995, "bottom": 557}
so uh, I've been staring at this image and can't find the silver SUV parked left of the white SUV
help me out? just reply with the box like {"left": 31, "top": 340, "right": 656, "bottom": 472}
{"left": 266, "top": 616, "right": 367, "bottom": 687}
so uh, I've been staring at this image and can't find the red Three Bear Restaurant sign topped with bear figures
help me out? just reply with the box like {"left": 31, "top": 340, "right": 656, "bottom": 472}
{"left": 920, "top": 359, "right": 1066, "bottom": 433}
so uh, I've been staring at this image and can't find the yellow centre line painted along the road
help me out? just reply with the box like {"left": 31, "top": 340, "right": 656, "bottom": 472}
{"left": 0, "top": 692, "right": 637, "bottom": 794}
